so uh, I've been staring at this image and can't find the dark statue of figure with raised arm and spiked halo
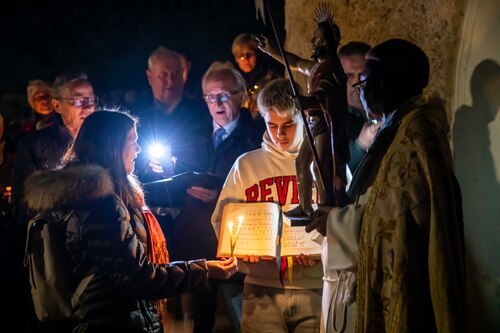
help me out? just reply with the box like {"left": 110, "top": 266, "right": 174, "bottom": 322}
{"left": 258, "top": 3, "right": 350, "bottom": 225}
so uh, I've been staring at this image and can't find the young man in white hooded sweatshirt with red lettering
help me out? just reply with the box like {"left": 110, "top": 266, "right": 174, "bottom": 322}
{"left": 212, "top": 79, "right": 323, "bottom": 333}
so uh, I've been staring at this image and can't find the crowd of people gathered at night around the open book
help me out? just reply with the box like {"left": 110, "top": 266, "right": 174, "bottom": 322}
{"left": 0, "top": 13, "right": 467, "bottom": 333}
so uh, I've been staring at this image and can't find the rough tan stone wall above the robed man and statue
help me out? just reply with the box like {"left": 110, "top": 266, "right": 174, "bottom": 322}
{"left": 285, "top": 0, "right": 467, "bottom": 114}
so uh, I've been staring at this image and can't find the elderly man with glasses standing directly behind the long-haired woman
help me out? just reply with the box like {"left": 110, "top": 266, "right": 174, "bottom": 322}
{"left": 12, "top": 73, "right": 98, "bottom": 223}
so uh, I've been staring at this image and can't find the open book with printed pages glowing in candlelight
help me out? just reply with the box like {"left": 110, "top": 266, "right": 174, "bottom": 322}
{"left": 217, "top": 202, "right": 321, "bottom": 259}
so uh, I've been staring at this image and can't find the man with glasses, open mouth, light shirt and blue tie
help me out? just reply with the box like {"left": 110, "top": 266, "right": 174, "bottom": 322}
{"left": 170, "top": 62, "right": 265, "bottom": 332}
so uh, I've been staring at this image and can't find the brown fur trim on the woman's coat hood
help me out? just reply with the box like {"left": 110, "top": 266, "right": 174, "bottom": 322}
{"left": 24, "top": 165, "right": 114, "bottom": 212}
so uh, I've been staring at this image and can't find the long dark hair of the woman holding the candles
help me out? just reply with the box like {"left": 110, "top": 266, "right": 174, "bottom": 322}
{"left": 64, "top": 110, "right": 144, "bottom": 209}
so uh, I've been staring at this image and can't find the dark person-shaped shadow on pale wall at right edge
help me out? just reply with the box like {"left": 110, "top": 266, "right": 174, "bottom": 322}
{"left": 453, "top": 59, "right": 500, "bottom": 332}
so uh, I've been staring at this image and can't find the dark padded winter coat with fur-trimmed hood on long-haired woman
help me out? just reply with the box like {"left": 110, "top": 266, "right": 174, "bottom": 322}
{"left": 26, "top": 165, "right": 207, "bottom": 332}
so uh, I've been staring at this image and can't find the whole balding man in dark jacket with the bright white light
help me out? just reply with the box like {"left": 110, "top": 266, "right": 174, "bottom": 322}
{"left": 136, "top": 46, "right": 209, "bottom": 274}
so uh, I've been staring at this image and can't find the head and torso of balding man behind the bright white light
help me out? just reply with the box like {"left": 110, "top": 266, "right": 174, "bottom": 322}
{"left": 136, "top": 46, "right": 209, "bottom": 182}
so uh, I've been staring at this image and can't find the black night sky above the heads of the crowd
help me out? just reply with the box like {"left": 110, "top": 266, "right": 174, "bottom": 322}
{"left": 0, "top": 0, "right": 284, "bottom": 100}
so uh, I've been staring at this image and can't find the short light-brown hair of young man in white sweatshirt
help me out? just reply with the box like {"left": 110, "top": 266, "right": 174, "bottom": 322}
{"left": 257, "top": 79, "right": 299, "bottom": 117}
